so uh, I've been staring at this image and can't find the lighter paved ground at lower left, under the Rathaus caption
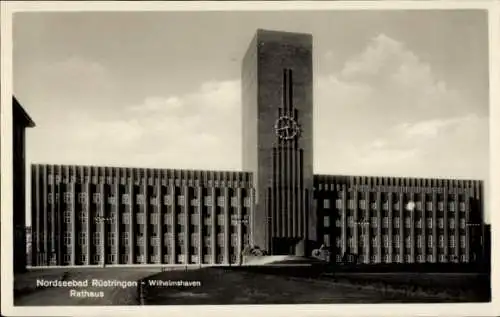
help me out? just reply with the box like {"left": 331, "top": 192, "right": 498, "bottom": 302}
{"left": 14, "top": 268, "right": 160, "bottom": 306}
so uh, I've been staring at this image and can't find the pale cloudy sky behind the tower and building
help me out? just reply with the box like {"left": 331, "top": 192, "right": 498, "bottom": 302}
{"left": 13, "top": 10, "right": 489, "bottom": 222}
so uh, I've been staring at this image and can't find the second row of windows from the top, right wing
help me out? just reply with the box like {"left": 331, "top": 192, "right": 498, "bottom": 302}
{"left": 332, "top": 216, "right": 466, "bottom": 229}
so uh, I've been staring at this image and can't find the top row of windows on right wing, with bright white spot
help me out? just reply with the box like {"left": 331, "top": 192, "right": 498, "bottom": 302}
{"left": 323, "top": 199, "right": 466, "bottom": 212}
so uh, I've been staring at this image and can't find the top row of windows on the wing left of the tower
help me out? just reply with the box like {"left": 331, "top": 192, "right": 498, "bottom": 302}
{"left": 47, "top": 192, "right": 251, "bottom": 208}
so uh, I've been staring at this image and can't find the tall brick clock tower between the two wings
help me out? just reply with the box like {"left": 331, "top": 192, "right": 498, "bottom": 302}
{"left": 242, "top": 30, "right": 317, "bottom": 256}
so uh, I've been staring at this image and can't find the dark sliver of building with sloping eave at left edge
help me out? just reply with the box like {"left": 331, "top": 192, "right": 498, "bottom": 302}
{"left": 12, "top": 97, "right": 35, "bottom": 273}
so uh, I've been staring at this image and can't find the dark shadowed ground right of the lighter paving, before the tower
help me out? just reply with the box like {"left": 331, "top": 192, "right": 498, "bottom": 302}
{"left": 142, "top": 266, "right": 488, "bottom": 305}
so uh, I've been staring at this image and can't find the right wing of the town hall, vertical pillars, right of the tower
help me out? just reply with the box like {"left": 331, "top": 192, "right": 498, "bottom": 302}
{"left": 315, "top": 175, "right": 486, "bottom": 263}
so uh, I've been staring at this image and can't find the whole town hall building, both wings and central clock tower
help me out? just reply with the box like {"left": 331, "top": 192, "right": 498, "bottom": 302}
{"left": 28, "top": 30, "right": 484, "bottom": 265}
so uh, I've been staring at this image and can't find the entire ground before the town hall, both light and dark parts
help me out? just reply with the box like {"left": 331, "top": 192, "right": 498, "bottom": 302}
{"left": 14, "top": 267, "right": 484, "bottom": 306}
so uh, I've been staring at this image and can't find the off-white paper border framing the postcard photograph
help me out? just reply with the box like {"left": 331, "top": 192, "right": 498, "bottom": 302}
{"left": 0, "top": 0, "right": 500, "bottom": 316}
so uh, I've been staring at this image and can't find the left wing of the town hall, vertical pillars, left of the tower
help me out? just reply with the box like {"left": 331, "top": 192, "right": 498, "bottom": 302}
{"left": 32, "top": 165, "right": 253, "bottom": 266}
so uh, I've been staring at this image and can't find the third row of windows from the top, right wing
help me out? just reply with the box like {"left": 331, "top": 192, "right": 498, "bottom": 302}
{"left": 332, "top": 235, "right": 467, "bottom": 249}
